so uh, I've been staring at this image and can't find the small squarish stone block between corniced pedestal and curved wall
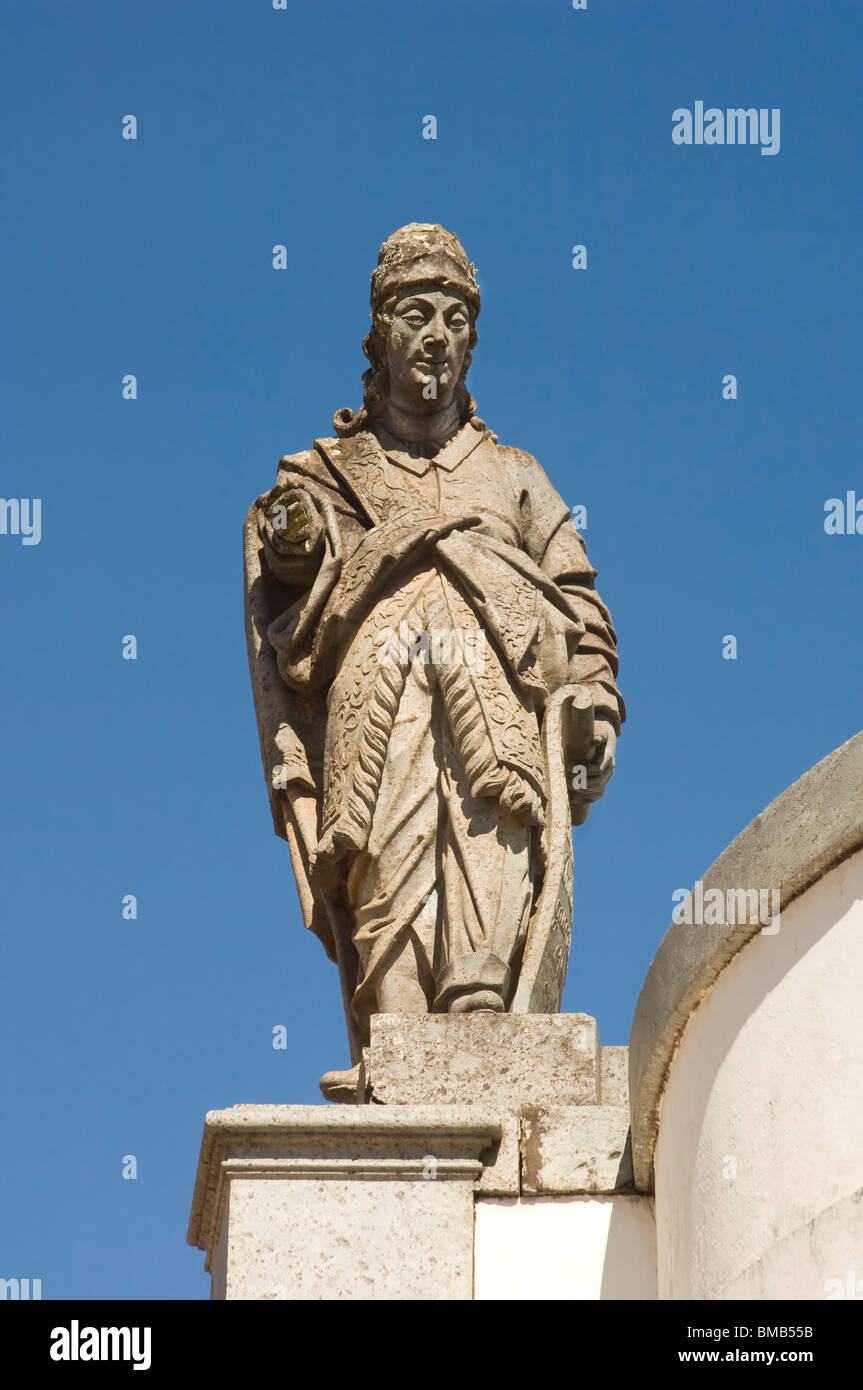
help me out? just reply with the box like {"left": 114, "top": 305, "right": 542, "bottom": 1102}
{"left": 521, "top": 1105, "right": 632, "bottom": 1195}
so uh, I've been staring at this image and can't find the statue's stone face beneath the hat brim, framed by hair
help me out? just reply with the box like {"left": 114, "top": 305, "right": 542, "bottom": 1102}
{"left": 386, "top": 285, "right": 471, "bottom": 411}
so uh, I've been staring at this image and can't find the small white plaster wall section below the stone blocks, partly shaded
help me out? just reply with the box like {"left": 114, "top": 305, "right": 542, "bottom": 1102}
{"left": 474, "top": 1194, "right": 656, "bottom": 1300}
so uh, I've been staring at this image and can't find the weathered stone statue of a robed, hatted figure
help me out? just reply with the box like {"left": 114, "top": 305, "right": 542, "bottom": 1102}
{"left": 245, "top": 224, "right": 625, "bottom": 1101}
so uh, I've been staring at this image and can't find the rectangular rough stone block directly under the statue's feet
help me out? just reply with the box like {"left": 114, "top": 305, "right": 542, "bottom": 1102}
{"left": 368, "top": 1013, "right": 599, "bottom": 1113}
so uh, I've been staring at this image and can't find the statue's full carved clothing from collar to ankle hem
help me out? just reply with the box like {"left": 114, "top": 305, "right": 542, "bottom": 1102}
{"left": 246, "top": 420, "right": 624, "bottom": 1055}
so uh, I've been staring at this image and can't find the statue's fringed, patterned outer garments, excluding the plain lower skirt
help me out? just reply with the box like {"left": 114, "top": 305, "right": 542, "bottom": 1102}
{"left": 245, "top": 420, "right": 625, "bottom": 1056}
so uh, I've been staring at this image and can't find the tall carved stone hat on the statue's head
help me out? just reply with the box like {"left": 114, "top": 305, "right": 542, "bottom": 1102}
{"left": 371, "top": 222, "right": 479, "bottom": 318}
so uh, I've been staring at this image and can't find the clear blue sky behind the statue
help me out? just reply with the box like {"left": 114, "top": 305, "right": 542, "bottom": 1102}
{"left": 0, "top": 0, "right": 863, "bottom": 1298}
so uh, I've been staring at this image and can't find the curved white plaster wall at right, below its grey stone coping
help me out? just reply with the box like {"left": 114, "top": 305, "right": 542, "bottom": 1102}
{"left": 655, "top": 852, "right": 863, "bottom": 1298}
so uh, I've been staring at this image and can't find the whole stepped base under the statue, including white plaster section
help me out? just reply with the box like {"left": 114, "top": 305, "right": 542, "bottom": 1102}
{"left": 189, "top": 1015, "right": 656, "bottom": 1300}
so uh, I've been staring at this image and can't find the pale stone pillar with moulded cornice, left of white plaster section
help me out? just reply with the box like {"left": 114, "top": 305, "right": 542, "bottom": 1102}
{"left": 189, "top": 1105, "right": 503, "bottom": 1300}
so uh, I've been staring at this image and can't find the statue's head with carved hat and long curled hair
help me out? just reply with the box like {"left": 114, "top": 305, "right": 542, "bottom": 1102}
{"left": 332, "top": 222, "right": 479, "bottom": 435}
